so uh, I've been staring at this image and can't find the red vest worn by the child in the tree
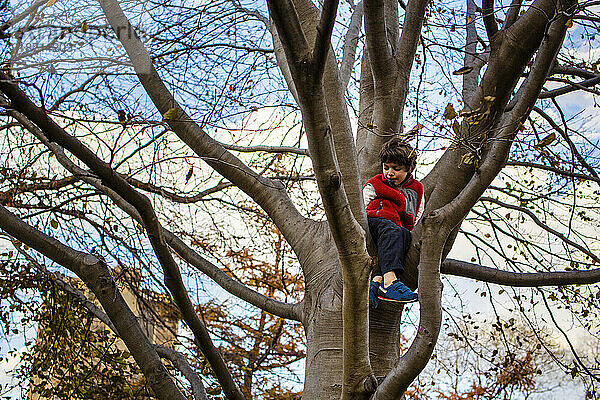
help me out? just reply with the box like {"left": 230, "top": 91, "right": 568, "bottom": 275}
{"left": 367, "top": 174, "right": 423, "bottom": 230}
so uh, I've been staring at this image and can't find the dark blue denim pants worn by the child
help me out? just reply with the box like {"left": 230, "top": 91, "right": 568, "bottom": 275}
{"left": 368, "top": 218, "right": 411, "bottom": 276}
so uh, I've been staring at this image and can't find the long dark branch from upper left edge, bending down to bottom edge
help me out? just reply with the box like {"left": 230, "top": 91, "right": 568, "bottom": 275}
{"left": 0, "top": 76, "right": 244, "bottom": 400}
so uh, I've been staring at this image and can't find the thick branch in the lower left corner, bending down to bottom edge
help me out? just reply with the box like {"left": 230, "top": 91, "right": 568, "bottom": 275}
{"left": 0, "top": 206, "right": 185, "bottom": 400}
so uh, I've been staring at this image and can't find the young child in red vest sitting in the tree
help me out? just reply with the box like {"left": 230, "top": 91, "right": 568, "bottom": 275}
{"left": 363, "top": 138, "right": 423, "bottom": 307}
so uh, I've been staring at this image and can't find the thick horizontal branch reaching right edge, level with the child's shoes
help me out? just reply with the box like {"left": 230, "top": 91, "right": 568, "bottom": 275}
{"left": 441, "top": 259, "right": 600, "bottom": 287}
